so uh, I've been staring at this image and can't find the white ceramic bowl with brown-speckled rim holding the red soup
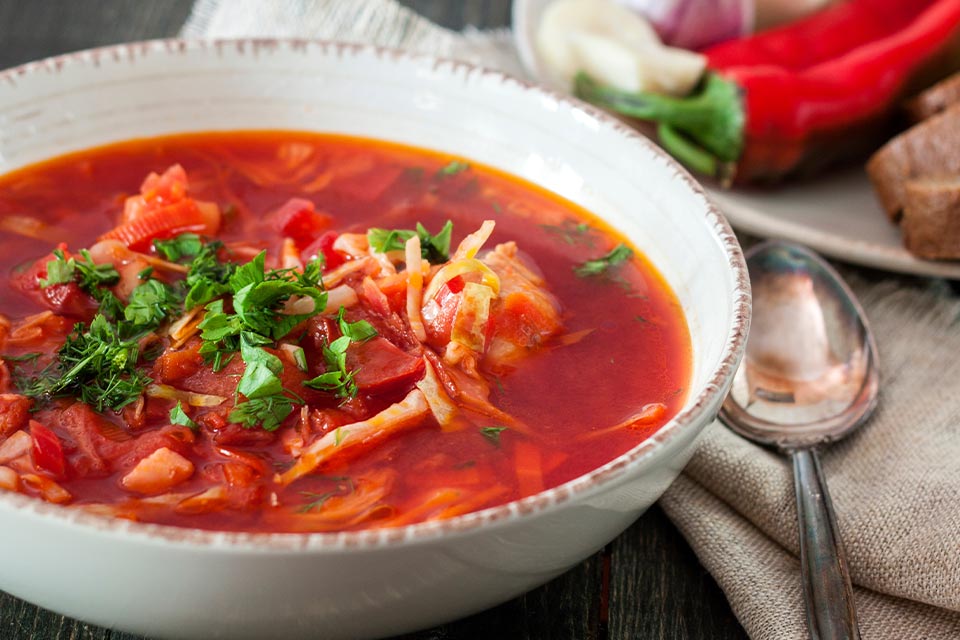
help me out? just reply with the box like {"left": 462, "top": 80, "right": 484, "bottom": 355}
{"left": 0, "top": 40, "right": 750, "bottom": 638}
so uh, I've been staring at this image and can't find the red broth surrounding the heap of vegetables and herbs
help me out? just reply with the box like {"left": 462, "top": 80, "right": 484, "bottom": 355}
{"left": 0, "top": 132, "right": 691, "bottom": 531}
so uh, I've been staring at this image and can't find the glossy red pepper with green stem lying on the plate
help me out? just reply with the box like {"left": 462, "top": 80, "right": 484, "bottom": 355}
{"left": 576, "top": 0, "right": 960, "bottom": 182}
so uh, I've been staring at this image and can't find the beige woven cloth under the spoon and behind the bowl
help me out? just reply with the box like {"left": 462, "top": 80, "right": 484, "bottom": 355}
{"left": 183, "top": 0, "right": 960, "bottom": 640}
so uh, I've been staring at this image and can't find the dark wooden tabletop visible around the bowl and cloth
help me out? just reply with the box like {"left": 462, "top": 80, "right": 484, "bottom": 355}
{"left": 0, "top": 0, "right": 746, "bottom": 640}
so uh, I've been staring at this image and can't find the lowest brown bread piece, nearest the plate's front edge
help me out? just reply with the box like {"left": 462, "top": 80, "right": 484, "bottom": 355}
{"left": 900, "top": 175, "right": 960, "bottom": 260}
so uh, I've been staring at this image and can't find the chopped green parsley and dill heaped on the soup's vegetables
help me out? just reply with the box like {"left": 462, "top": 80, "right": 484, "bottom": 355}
{"left": 17, "top": 230, "right": 360, "bottom": 431}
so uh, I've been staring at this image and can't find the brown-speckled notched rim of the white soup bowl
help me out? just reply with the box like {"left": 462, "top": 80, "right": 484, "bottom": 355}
{"left": 0, "top": 38, "right": 751, "bottom": 553}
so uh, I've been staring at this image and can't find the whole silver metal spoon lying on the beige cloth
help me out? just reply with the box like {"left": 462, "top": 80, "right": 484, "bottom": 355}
{"left": 720, "top": 242, "right": 879, "bottom": 640}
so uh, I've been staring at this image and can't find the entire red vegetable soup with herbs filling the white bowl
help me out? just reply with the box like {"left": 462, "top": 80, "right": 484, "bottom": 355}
{"left": 0, "top": 132, "right": 691, "bottom": 531}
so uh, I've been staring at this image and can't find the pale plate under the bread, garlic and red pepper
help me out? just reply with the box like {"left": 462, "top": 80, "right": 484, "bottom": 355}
{"left": 513, "top": 0, "right": 960, "bottom": 279}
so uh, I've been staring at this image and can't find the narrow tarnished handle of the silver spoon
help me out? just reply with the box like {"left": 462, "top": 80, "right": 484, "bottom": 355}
{"left": 791, "top": 449, "right": 860, "bottom": 640}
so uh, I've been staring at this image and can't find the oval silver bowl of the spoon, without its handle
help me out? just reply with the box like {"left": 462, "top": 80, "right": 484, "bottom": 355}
{"left": 722, "top": 242, "right": 879, "bottom": 450}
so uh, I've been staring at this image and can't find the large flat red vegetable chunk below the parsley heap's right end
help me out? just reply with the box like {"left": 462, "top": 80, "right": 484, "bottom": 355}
{"left": 347, "top": 337, "right": 423, "bottom": 393}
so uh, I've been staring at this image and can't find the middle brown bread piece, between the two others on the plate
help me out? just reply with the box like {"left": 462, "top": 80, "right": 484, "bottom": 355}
{"left": 867, "top": 103, "right": 960, "bottom": 221}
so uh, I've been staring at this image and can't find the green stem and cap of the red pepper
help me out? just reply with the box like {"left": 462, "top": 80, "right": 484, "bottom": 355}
{"left": 574, "top": 72, "right": 745, "bottom": 166}
